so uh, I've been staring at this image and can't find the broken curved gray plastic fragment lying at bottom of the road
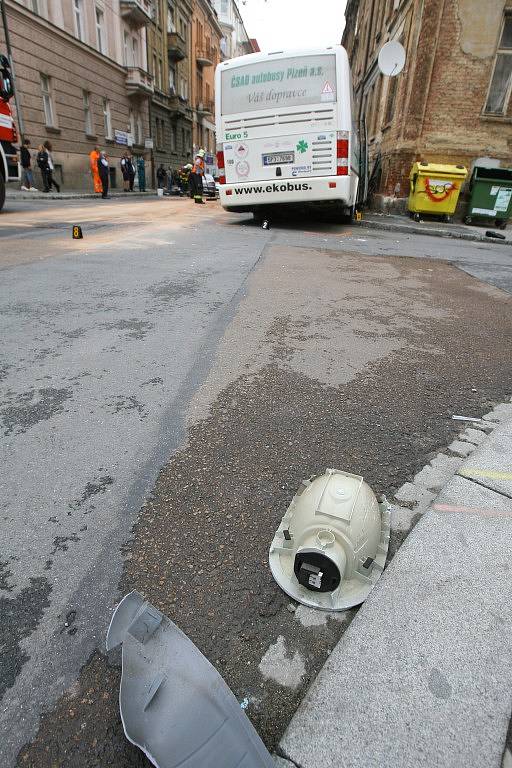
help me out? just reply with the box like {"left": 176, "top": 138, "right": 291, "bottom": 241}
{"left": 106, "top": 592, "right": 274, "bottom": 768}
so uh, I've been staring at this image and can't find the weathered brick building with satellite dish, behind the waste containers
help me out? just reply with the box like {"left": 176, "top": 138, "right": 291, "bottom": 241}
{"left": 342, "top": 0, "right": 512, "bottom": 197}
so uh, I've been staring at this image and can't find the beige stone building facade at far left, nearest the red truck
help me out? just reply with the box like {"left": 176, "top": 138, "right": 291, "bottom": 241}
{"left": 0, "top": 0, "right": 153, "bottom": 189}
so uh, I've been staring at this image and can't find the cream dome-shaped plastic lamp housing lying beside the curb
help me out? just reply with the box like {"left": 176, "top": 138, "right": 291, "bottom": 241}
{"left": 269, "top": 469, "right": 390, "bottom": 611}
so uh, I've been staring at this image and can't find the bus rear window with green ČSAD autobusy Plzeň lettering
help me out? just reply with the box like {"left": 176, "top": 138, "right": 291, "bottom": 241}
{"left": 221, "top": 53, "right": 336, "bottom": 115}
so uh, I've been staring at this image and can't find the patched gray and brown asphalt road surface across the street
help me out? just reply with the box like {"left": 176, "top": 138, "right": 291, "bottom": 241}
{"left": 0, "top": 195, "right": 512, "bottom": 768}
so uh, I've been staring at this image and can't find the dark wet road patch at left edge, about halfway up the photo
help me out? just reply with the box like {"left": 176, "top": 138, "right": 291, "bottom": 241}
{"left": 0, "top": 387, "right": 73, "bottom": 435}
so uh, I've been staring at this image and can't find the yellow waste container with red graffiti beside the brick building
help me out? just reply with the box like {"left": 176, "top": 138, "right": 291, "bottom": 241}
{"left": 409, "top": 163, "right": 468, "bottom": 221}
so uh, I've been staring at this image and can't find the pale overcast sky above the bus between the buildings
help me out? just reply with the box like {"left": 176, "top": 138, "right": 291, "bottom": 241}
{"left": 237, "top": 0, "right": 346, "bottom": 52}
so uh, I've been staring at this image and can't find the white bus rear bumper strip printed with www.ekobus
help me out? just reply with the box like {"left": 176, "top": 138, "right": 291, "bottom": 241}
{"left": 220, "top": 176, "right": 357, "bottom": 211}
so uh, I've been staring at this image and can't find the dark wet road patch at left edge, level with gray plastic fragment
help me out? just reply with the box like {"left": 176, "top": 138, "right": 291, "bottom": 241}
{"left": 0, "top": 576, "right": 52, "bottom": 704}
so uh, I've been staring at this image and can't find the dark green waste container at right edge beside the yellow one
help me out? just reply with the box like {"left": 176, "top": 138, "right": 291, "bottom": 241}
{"left": 464, "top": 165, "right": 512, "bottom": 229}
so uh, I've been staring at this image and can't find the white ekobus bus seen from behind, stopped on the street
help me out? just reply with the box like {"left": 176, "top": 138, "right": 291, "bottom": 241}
{"left": 215, "top": 46, "right": 359, "bottom": 219}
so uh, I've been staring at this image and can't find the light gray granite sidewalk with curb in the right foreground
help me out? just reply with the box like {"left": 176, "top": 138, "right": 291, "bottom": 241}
{"left": 277, "top": 405, "right": 512, "bottom": 768}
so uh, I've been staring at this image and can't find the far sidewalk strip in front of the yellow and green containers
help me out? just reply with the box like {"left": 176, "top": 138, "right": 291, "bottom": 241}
{"left": 360, "top": 211, "right": 512, "bottom": 245}
